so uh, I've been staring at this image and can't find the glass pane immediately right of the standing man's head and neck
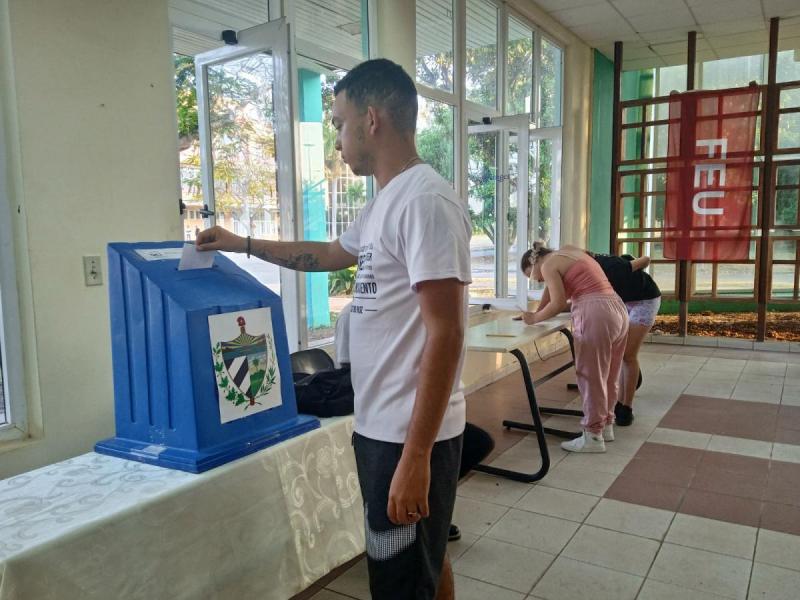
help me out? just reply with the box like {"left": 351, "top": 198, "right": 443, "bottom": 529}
{"left": 417, "top": 96, "right": 455, "bottom": 184}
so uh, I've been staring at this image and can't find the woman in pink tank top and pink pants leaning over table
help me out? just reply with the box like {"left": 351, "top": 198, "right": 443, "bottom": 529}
{"left": 520, "top": 242, "right": 628, "bottom": 452}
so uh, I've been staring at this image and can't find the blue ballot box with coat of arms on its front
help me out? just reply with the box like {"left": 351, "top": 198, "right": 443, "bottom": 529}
{"left": 95, "top": 242, "right": 319, "bottom": 473}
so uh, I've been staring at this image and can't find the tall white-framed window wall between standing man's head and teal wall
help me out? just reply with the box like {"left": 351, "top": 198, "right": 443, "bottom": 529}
{"left": 416, "top": 0, "right": 564, "bottom": 303}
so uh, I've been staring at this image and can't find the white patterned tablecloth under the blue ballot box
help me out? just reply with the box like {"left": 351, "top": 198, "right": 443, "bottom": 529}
{"left": 0, "top": 417, "right": 364, "bottom": 600}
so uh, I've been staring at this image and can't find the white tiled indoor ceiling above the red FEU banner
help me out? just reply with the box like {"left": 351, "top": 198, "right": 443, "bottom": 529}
{"left": 534, "top": 0, "right": 800, "bottom": 70}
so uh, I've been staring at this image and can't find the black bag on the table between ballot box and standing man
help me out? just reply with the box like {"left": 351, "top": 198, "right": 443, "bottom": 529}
{"left": 293, "top": 367, "right": 353, "bottom": 417}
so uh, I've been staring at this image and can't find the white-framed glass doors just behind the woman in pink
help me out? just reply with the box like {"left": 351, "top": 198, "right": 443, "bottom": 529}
{"left": 467, "top": 114, "right": 561, "bottom": 309}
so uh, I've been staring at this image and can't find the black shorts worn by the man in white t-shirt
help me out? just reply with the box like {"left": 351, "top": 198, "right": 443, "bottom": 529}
{"left": 353, "top": 433, "right": 463, "bottom": 600}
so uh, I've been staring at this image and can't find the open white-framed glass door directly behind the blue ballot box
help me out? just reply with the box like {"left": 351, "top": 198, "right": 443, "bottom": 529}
{"left": 195, "top": 19, "right": 299, "bottom": 351}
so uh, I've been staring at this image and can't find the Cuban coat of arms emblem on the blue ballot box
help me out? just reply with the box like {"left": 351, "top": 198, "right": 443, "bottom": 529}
{"left": 208, "top": 308, "right": 282, "bottom": 423}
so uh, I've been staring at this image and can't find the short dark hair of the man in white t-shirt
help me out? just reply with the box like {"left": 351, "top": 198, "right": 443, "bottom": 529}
{"left": 333, "top": 58, "right": 417, "bottom": 132}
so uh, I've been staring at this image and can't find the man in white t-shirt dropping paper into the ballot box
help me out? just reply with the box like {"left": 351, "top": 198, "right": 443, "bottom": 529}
{"left": 197, "top": 59, "right": 471, "bottom": 600}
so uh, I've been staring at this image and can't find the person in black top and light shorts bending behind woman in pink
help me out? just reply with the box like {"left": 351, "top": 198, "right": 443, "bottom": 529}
{"left": 586, "top": 250, "right": 661, "bottom": 427}
